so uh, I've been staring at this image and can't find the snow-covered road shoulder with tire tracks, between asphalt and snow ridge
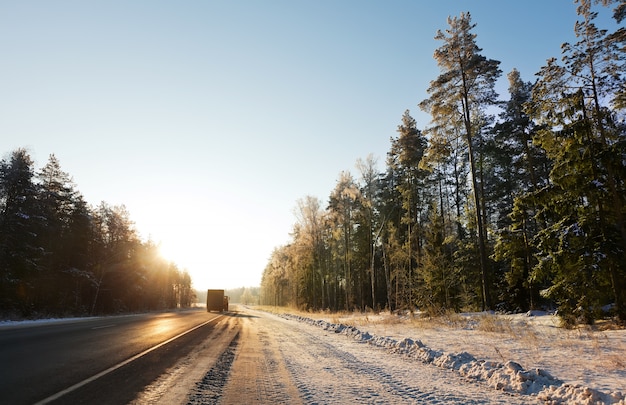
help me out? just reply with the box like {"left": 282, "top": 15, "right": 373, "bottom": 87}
{"left": 229, "top": 308, "right": 536, "bottom": 405}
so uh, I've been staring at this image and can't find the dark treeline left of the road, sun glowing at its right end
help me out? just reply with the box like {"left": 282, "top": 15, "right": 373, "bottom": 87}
{"left": 0, "top": 149, "right": 194, "bottom": 317}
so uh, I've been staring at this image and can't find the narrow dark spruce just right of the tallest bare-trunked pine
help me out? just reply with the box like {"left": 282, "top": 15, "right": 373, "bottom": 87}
{"left": 491, "top": 70, "right": 550, "bottom": 311}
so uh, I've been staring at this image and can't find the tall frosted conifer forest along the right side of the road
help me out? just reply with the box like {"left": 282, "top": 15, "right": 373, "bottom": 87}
{"left": 261, "top": 0, "right": 626, "bottom": 324}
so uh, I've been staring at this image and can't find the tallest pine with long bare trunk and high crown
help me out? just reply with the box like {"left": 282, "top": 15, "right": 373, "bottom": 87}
{"left": 420, "top": 13, "right": 501, "bottom": 308}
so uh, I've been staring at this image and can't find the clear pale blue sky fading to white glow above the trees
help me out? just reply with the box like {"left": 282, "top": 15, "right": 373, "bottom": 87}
{"left": 0, "top": 0, "right": 608, "bottom": 289}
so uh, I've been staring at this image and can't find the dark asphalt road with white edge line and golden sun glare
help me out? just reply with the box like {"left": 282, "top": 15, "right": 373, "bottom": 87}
{"left": 0, "top": 310, "right": 220, "bottom": 405}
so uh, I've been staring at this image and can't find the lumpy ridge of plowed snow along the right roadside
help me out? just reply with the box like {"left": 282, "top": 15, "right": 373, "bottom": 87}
{"left": 281, "top": 314, "right": 626, "bottom": 405}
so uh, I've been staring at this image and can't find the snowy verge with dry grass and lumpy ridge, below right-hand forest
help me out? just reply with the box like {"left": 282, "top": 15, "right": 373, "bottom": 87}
{"left": 272, "top": 312, "right": 626, "bottom": 404}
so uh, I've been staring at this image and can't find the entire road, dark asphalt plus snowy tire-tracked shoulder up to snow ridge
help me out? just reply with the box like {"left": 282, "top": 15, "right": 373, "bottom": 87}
{"left": 0, "top": 307, "right": 532, "bottom": 405}
